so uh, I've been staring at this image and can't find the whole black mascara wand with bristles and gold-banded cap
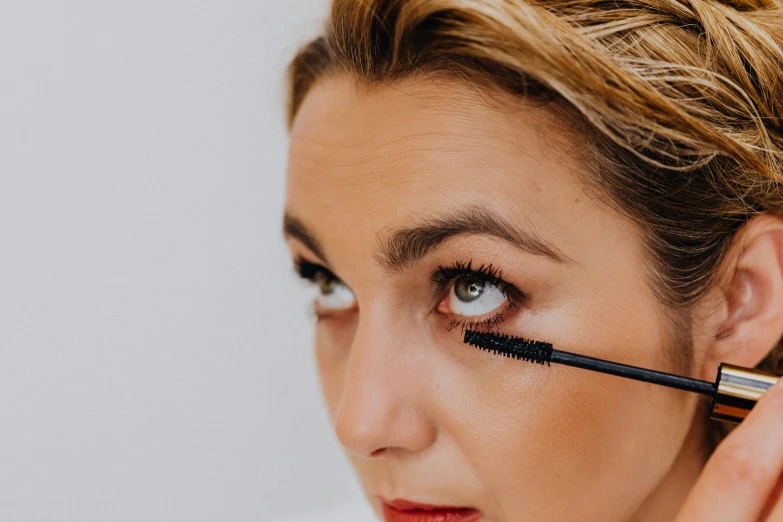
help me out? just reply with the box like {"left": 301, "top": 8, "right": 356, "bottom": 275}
{"left": 464, "top": 330, "right": 780, "bottom": 422}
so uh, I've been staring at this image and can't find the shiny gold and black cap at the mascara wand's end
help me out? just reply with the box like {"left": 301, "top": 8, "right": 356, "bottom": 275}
{"left": 711, "top": 363, "right": 780, "bottom": 422}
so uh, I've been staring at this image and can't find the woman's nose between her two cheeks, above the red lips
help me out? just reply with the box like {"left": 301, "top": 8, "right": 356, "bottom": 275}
{"left": 333, "top": 316, "right": 436, "bottom": 458}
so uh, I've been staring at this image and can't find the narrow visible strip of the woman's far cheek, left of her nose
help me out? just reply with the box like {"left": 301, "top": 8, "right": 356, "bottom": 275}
{"left": 315, "top": 314, "right": 357, "bottom": 419}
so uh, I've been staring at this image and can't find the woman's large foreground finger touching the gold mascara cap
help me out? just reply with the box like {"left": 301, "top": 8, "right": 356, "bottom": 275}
{"left": 677, "top": 379, "right": 783, "bottom": 522}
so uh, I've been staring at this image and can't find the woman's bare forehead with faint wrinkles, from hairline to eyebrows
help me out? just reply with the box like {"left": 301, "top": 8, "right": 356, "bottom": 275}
{"left": 286, "top": 76, "right": 632, "bottom": 264}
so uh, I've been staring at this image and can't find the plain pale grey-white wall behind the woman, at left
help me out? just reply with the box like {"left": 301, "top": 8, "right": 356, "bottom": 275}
{"left": 0, "top": 0, "right": 370, "bottom": 522}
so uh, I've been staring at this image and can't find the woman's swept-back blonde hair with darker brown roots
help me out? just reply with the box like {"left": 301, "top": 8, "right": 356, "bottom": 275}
{"left": 288, "top": 0, "right": 783, "bottom": 434}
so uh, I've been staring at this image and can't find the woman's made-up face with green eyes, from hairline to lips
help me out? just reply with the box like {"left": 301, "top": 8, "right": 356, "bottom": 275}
{"left": 285, "top": 77, "right": 703, "bottom": 522}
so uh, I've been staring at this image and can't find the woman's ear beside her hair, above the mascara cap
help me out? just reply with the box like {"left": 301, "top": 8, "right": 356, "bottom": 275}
{"left": 697, "top": 214, "right": 783, "bottom": 380}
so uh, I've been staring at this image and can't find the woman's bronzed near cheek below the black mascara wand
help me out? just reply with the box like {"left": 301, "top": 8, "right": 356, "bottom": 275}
{"left": 440, "top": 344, "right": 700, "bottom": 521}
